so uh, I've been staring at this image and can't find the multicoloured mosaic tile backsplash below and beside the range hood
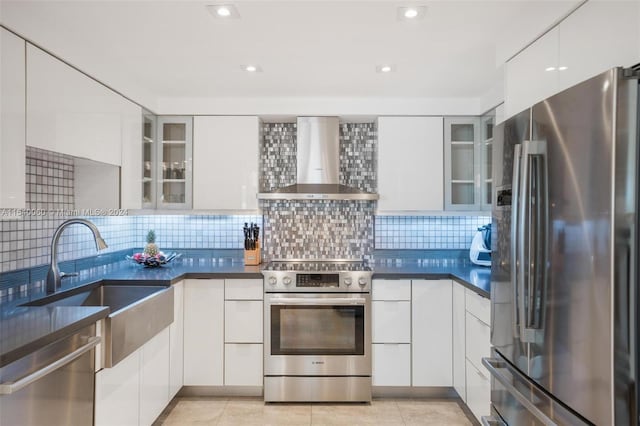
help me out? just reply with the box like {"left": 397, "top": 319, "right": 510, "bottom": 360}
{"left": 260, "top": 123, "right": 378, "bottom": 260}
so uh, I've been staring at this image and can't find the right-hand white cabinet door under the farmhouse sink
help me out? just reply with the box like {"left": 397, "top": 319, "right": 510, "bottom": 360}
{"left": 139, "top": 327, "right": 170, "bottom": 426}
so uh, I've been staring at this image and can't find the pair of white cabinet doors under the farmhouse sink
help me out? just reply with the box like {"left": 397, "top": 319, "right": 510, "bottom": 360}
{"left": 95, "top": 327, "right": 170, "bottom": 426}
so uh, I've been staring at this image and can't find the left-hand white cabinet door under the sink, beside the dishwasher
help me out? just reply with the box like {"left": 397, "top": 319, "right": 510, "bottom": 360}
{"left": 94, "top": 348, "right": 142, "bottom": 426}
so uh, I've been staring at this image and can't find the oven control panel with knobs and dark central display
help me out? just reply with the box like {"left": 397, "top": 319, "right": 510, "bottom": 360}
{"left": 262, "top": 270, "right": 372, "bottom": 293}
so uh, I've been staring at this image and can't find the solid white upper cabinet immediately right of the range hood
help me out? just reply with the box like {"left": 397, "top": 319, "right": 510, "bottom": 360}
{"left": 378, "top": 117, "right": 444, "bottom": 212}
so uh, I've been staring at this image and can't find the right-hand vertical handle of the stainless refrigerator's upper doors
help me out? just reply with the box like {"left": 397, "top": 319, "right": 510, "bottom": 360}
{"left": 517, "top": 141, "right": 548, "bottom": 342}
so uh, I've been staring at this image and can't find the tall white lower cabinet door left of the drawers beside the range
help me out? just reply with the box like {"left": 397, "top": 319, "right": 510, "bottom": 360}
{"left": 184, "top": 279, "right": 224, "bottom": 386}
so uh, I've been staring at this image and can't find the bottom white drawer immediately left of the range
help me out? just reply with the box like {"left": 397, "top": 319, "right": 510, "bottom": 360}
{"left": 224, "top": 343, "right": 264, "bottom": 386}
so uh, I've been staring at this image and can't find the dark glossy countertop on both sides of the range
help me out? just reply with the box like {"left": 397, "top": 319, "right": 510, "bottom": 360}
{"left": 0, "top": 250, "right": 491, "bottom": 367}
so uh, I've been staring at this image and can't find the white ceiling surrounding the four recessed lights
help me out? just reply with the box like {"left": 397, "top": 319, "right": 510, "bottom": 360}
{"left": 0, "top": 0, "right": 580, "bottom": 109}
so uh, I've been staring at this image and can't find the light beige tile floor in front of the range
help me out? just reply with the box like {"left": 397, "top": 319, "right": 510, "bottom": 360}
{"left": 154, "top": 397, "right": 473, "bottom": 426}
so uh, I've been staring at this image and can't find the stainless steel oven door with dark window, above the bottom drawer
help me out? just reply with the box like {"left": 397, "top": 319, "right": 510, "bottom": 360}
{"left": 264, "top": 293, "right": 371, "bottom": 376}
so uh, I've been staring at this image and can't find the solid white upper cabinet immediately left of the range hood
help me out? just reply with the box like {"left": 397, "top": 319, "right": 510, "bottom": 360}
{"left": 193, "top": 116, "right": 260, "bottom": 210}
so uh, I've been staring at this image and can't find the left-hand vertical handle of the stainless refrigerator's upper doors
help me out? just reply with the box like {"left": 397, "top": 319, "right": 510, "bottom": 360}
{"left": 510, "top": 144, "right": 522, "bottom": 337}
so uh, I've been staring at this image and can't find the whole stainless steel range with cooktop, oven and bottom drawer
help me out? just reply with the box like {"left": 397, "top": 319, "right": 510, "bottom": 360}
{"left": 262, "top": 261, "right": 372, "bottom": 402}
